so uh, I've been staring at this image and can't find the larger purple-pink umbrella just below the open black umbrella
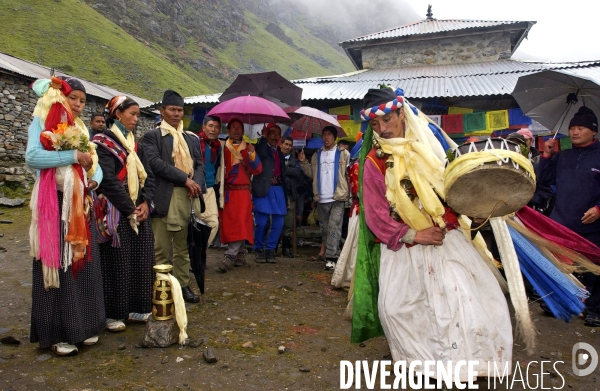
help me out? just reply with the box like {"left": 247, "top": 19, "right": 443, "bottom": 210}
{"left": 208, "top": 96, "right": 290, "bottom": 124}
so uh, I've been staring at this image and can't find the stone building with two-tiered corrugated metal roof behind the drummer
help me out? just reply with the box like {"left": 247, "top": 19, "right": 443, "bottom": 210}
{"left": 186, "top": 10, "right": 600, "bottom": 127}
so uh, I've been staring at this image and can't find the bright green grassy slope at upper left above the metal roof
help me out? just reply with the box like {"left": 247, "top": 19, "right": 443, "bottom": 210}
{"left": 0, "top": 0, "right": 217, "bottom": 100}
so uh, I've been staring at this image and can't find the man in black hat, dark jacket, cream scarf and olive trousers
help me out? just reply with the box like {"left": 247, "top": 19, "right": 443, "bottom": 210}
{"left": 142, "top": 90, "right": 204, "bottom": 303}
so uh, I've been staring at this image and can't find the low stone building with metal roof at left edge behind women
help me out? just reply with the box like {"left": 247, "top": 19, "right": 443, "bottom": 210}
{"left": 0, "top": 53, "right": 156, "bottom": 184}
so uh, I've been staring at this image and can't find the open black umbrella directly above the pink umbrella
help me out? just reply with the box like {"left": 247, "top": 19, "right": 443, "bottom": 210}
{"left": 219, "top": 71, "right": 302, "bottom": 106}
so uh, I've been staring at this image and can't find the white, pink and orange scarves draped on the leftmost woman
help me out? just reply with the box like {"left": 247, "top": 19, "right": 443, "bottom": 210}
{"left": 29, "top": 78, "right": 98, "bottom": 289}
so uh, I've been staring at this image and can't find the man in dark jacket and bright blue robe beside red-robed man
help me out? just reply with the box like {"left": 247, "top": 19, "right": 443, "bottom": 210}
{"left": 252, "top": 123, "right": 287, "bottom": 263}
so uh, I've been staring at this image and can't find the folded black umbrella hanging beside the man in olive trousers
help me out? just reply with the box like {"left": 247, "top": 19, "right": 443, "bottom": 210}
{"left": 187, "top": 201, "right": 211, "bottom": 295}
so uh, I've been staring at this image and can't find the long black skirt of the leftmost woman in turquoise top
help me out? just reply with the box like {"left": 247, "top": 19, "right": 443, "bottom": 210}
{"left": 30, "top": 192, "right": 106, "bottom": 348}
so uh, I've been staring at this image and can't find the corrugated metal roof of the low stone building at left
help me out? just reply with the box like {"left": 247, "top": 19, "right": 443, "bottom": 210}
{"left": 0, "top": 53, "right": 152, "bottom": 107}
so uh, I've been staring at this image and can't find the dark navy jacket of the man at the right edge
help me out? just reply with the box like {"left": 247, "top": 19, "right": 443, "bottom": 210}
{"left": 538, "top": 140, "right": 600, "bottom": 233}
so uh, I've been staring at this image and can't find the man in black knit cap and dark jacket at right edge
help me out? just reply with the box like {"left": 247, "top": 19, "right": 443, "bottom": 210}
{"left": 538, "top": 106, "right": 600, "bottom": 327}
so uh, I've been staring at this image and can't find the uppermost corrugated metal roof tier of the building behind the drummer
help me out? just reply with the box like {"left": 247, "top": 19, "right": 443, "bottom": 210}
{"left": 340, "top": 19, "right": 535, "bottom": 45}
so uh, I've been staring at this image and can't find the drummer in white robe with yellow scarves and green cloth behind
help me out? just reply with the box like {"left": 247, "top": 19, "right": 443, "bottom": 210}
{"left": 352, "top": 88, "right": 512, "bottom": 381}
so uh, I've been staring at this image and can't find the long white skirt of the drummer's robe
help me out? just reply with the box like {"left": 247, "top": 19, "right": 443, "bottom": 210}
{"left": 378, "top": 230, "right": 513, "bottom": 381}
